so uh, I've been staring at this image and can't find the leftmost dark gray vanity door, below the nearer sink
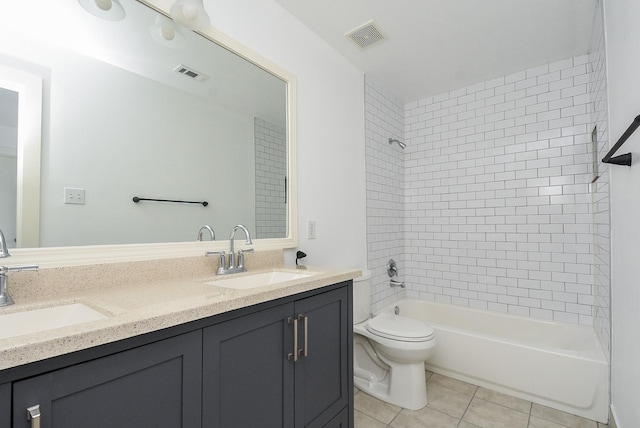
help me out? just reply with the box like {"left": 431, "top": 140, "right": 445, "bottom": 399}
{"left": 13, "top": 331, "right": 202, "bottom": 428}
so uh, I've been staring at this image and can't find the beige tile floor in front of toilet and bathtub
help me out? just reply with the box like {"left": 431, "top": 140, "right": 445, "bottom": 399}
{"left": 355, "top": 372, "right": 607, "bottom": 428}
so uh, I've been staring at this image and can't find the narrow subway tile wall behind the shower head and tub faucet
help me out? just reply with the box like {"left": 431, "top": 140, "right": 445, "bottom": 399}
{"left": 364, "top": 76, "right": 405, "bottom": 311}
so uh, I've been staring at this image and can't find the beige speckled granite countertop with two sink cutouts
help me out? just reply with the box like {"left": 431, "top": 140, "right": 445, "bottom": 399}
{"left": 0, "top": 254, "right": 361, "bottom": 370}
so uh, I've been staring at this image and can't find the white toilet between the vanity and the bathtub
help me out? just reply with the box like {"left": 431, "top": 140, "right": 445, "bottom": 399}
{"left": 353, "top": 273, "right": 436, "bottom": 410}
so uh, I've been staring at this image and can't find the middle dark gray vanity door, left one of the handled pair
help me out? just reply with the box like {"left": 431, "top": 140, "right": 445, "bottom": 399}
{"left": 202, "top": 303, "right": 294, "bottom": 428}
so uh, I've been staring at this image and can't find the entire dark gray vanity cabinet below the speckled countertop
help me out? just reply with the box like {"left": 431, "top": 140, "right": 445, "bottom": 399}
{"left": 0, "top": 281, "right": 353, "bottom": 428}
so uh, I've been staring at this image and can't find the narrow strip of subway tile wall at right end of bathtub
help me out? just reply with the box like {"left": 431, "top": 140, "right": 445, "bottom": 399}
{"left": 589, "top": 2, "right": 611, "bottom": 358}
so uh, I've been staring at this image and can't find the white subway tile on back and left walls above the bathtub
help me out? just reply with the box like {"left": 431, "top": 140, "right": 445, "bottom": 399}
{"left": 365, "top": 55, "right": 608, "bottom": 324}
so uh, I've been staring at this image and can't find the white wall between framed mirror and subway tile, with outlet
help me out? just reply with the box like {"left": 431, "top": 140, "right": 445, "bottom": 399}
{"left": 205, "top": 0, "right": 367, "bottom": 268}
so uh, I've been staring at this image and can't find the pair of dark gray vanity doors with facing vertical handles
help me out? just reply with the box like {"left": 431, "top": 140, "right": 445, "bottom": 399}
{"left": 203, "top": 286, "right": 352, "bottom": 428}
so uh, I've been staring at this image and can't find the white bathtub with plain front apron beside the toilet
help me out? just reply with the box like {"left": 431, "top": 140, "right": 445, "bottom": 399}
{"left": 380, "top": 299, "right": 609, "bottom": 423}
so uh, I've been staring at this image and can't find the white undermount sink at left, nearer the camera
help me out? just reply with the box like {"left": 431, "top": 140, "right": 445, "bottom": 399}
{"left": 0, "top": 303, "right": 107, "bottom": 339}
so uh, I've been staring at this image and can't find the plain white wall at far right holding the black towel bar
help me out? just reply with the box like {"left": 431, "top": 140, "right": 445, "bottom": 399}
{"left": 604, "top": 0, "right": 640, "bottom": 428}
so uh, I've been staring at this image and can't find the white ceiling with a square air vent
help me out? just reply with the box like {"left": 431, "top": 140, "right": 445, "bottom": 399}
{"left": 276, "top": 0, "right": 597, "bottom": 102}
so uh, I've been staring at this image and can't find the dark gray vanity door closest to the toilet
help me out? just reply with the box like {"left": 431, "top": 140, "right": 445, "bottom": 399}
{"left": 295, "top": 287, "right": 353, "bottom": 427}
